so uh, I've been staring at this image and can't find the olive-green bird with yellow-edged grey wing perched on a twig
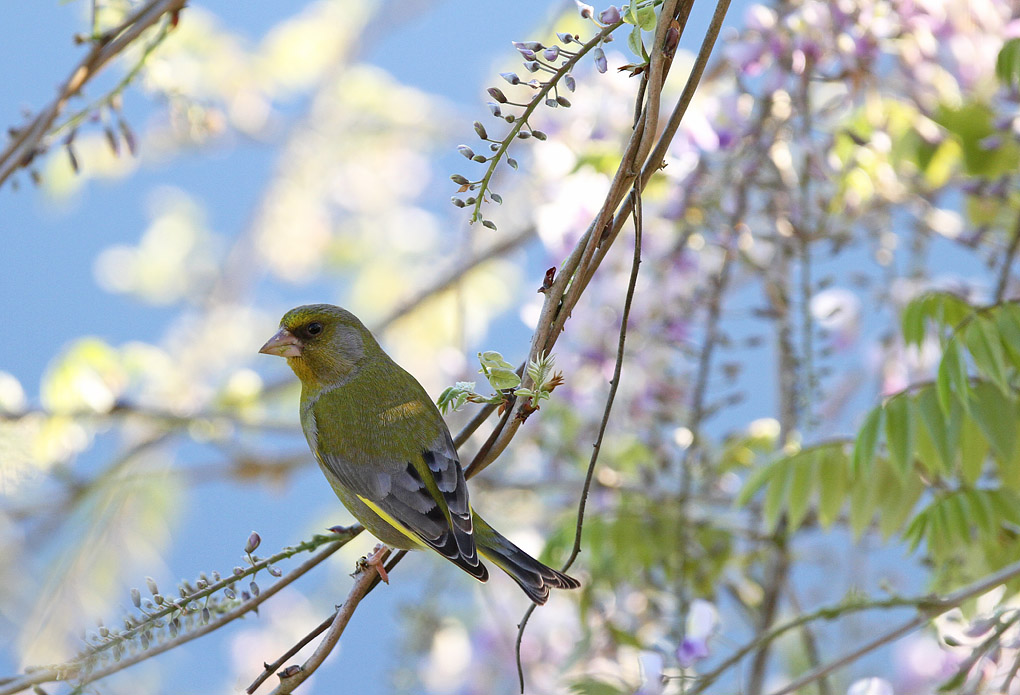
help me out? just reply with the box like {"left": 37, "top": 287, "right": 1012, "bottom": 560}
{"left": 259, "top": 304, "right": 579, "bottom": 604}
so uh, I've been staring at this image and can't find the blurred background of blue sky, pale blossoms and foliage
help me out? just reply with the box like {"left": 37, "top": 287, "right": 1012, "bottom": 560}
{"left": 0, "top": 0, "right": 1018, "bottom": 694}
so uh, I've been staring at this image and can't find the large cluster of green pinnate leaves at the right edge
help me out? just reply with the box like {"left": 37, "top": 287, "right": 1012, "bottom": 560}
{"left": 737, "top": 293, "right": 1020, "bottom": 579}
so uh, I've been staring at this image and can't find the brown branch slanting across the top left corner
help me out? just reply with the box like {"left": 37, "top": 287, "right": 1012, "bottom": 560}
{"left": 0, "top": 0, "right": 187, "bottom": 186}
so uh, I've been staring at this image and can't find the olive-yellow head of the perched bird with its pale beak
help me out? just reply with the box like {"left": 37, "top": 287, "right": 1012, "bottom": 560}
{"left": 259, "top": 304, "right": 376, "bottom": 386}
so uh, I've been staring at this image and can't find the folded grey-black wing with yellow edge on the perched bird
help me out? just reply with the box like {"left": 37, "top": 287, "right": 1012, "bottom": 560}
{"left": 313, "top": 395, "right": 488, "bottom": 581}
